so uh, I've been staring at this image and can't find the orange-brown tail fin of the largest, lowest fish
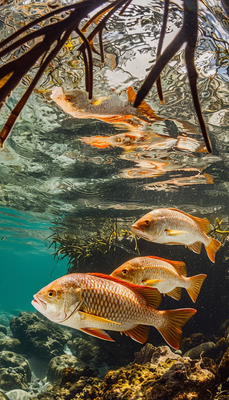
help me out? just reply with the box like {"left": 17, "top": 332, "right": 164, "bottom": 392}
{"left": 157, "top": 308, "right": 196, "bottom": 349}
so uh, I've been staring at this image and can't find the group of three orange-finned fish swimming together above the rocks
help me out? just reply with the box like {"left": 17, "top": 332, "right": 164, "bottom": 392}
{"left": 32, "top": 208, "right": 221, "bottom": 349}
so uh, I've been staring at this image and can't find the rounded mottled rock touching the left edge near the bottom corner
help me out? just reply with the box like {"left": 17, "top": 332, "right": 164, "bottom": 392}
{"left": 0, "top": 351, "right": 31, "bottom": 390}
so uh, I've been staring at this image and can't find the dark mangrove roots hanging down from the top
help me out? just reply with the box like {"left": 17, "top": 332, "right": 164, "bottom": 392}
{"left": 0, "top": 0, "right": 220, "bottom": 153}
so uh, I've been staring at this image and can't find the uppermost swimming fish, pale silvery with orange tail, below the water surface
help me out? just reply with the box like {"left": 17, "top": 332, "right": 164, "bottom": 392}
{"left": 132, "top": 208, "right": 221, "bottom": 263}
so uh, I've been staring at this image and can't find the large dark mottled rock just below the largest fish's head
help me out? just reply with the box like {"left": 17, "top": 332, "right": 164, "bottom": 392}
{"left": 10, "top": 311, "right": 71, "bottom": 361}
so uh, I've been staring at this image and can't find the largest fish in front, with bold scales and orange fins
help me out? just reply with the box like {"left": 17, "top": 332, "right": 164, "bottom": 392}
{"left": 32, "top": 273, "right": 196, "bottom": 349}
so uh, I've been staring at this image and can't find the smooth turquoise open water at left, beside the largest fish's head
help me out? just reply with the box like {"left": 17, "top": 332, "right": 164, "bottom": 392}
{"left": 0, "top": 208, "right": 67, "bottom": 312}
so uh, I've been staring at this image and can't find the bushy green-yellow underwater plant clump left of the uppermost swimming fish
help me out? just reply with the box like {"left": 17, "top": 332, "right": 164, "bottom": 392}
{"left": 49, "top": 218, "right": 140, "bottom": 273}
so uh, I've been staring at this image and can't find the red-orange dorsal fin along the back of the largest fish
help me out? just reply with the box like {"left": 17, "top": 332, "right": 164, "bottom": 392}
{"left": 88, "top": 272, "right": 161, "bottom": 309}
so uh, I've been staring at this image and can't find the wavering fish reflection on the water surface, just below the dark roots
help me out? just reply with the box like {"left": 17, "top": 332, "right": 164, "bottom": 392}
{"left": 50, "top": 86, "right": 162, "bottom": 126}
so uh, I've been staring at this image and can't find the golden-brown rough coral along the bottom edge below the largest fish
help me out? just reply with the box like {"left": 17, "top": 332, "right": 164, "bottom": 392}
{"left": 26, "top": 344, "right": 220, "bottom": 400}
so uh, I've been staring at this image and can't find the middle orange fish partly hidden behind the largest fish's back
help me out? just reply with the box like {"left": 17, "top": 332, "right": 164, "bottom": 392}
{"left": 111, "top": 256, "right": 207, "bottom": 303}
